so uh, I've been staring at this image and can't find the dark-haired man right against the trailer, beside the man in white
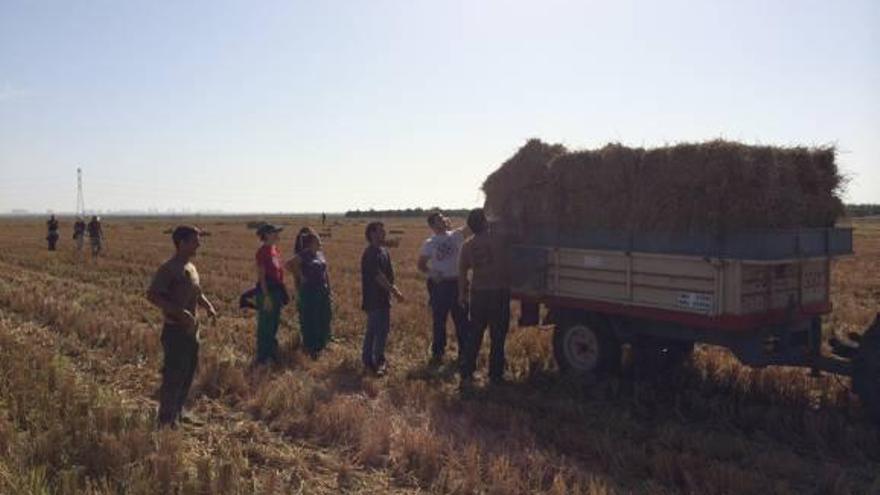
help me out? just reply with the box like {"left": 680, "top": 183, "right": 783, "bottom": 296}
{"left": 458, "top": 208, "right": 510, "bottom": 388}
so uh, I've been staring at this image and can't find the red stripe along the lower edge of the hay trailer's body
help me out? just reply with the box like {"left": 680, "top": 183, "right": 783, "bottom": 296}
{"left": 513, "top": 294, "right": 831, "bottom": 331}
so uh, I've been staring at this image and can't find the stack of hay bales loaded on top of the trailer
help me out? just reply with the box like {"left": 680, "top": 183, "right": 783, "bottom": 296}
{"left": 483, "top": 139, "right": 843, "bottom": 240}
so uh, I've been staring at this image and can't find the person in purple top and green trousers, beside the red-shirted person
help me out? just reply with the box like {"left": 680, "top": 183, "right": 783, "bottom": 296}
{"left": 284, "top": 231, "right": 331, "bottom": 359}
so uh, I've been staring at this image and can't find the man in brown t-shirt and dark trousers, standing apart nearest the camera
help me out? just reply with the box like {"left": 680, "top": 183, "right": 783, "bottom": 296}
{"left": 147, "top": 225, "right": 217, "bottom": 426}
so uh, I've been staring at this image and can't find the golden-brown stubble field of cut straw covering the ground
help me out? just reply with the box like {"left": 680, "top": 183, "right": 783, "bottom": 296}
{"left": 0, "top": 218, "right": 880, "bottom": 495}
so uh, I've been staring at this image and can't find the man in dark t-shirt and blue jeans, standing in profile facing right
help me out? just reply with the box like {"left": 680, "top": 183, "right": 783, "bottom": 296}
{"left": 361, "top": 222, "right": 404, "bottom": 376}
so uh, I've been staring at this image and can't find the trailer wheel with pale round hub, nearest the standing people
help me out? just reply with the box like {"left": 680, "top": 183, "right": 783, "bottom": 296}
{"left": 553, "top": 322, "right": 620, "bottom": 376}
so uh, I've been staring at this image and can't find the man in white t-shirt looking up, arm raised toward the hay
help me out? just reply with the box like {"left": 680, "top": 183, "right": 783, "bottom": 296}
{"left": 419, "top": 212, "right": 470, "bottom": 365}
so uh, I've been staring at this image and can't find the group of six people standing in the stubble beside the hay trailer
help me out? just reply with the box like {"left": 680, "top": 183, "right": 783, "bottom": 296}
{"left": 147, "top": 209, "right": 510, "bottom": 425}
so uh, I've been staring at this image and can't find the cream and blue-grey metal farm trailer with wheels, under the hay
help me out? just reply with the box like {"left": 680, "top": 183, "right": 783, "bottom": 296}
{"left": 512, "top": 228, "right": 880, "bottom": 419}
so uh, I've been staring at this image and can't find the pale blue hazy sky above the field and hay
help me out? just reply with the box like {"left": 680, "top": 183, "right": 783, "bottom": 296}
{"left": 0, "top": 0, "right": 880, "bottom": 212}
